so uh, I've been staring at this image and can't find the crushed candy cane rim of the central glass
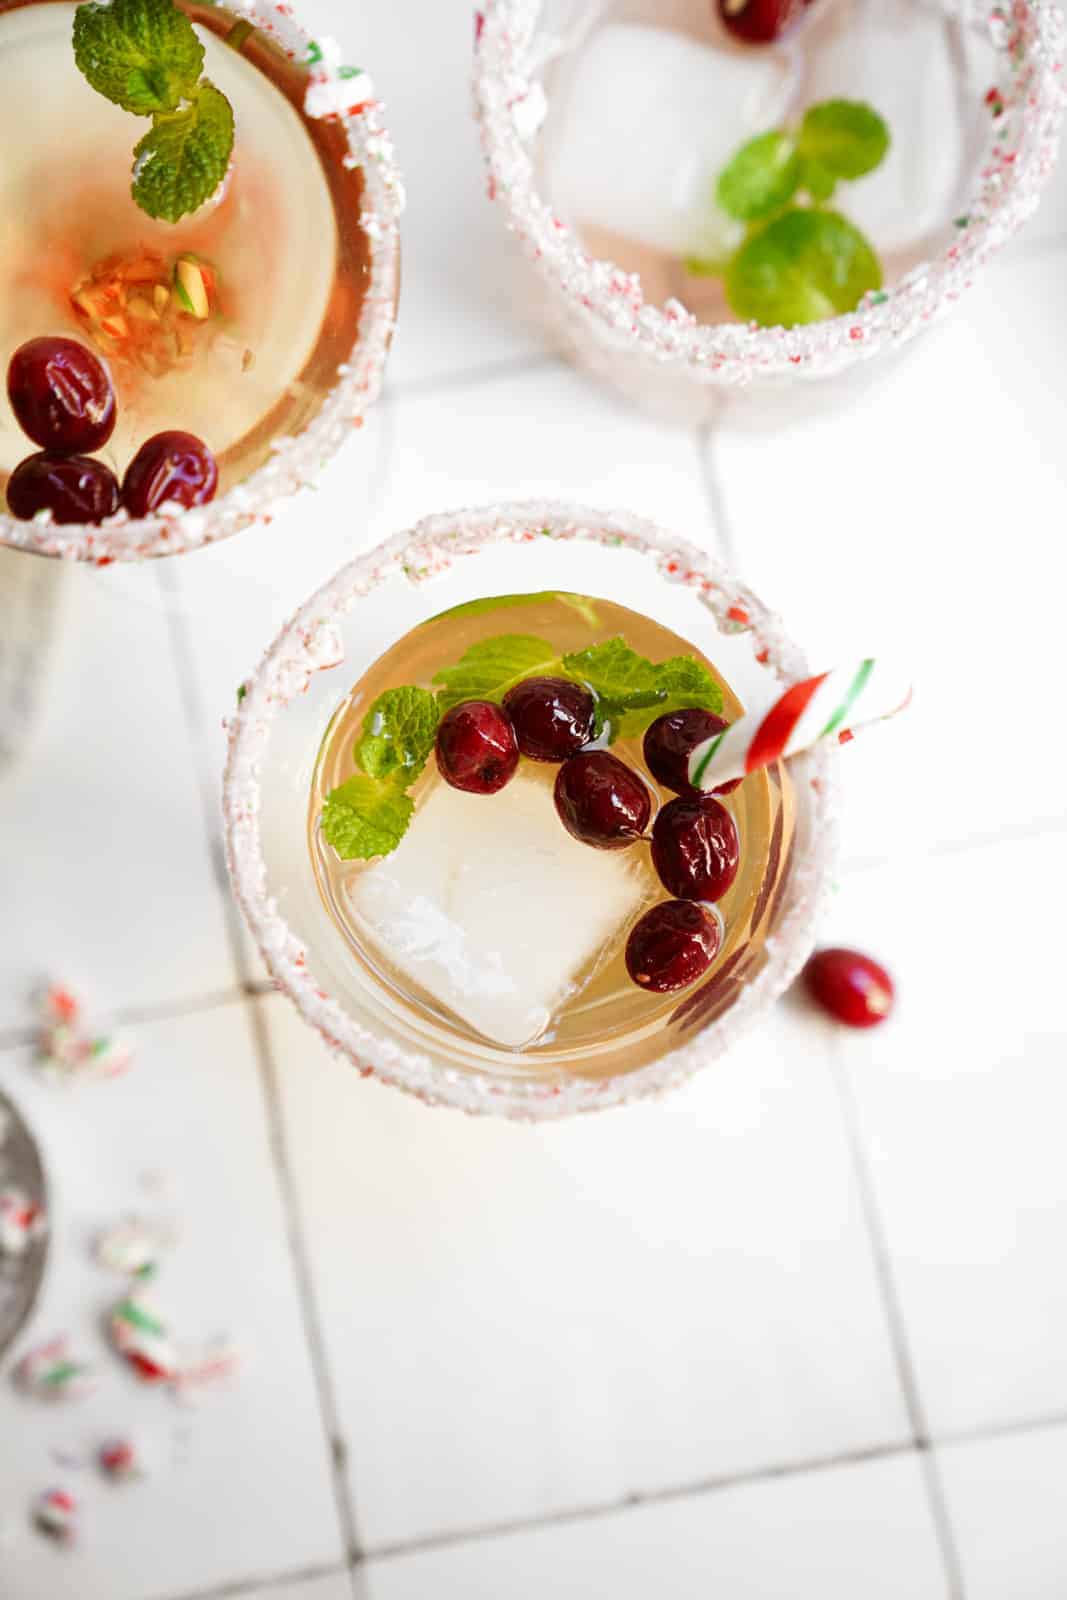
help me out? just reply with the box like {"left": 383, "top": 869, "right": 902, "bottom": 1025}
{"left": 222, "top": 501, "right": 837, "bottom": 1120}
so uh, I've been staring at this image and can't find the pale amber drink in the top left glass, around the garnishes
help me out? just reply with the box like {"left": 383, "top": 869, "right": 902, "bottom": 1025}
{"left": 0, "top": 0, "right": 368, "bottom": 490}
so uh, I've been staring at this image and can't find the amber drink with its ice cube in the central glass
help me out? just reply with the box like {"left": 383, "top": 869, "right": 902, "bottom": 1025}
{"left": 309, "top": 595, "right": 793, "bottom": 1074}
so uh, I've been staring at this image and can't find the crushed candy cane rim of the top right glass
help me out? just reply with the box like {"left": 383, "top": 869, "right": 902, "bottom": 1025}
{"left": 474, "top": 0, "right": 1065, "bottom": 387}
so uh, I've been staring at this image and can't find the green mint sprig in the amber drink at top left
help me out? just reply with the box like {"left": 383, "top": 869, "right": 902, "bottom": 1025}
{"left": 74, "top": 0, "right": 234, "bottom": 222}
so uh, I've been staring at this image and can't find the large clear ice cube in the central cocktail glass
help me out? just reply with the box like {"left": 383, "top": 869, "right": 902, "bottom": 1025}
{"left": 347, "top": 774, "right": 653, "bottom": 1050}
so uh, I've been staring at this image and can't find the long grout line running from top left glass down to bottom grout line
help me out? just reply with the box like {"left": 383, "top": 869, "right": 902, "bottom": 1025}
{"left": 160, "top": 569, "right": 367, "bottom": 1566}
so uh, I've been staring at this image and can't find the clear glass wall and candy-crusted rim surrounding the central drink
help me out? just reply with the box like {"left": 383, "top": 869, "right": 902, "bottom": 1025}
{"left": 224, "top": 502, "right": 837, "bottom": 1118}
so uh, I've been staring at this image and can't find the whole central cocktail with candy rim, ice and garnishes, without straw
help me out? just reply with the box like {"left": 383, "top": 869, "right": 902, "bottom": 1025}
{"left": 226, "top": 502, "right": 835, "bottom": 1117}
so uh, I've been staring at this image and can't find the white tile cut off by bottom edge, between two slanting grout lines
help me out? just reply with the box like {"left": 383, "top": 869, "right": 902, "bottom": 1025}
{"left": 368, "top": 1456, "right": 945, "bottom": 1600}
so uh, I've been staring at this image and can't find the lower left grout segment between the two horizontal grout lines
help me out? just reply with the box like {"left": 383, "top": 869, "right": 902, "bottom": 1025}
{"left": 246, "top": 995, "right": 363, "bottom": 1568}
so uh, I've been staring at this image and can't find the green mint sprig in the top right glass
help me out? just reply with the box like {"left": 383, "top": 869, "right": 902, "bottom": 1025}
{"left": 697, "top": 99, "right": 889, "bottom": 326}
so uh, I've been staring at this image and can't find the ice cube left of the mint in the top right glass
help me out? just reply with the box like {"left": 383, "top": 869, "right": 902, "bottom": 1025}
{"left": 544, "top": 22, "right": 793, "bottom": 256}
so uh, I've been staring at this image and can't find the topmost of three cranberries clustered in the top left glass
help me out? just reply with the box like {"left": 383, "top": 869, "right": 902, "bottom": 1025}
{"left": 8, "top": 339, "right": 115, "bottom": 454}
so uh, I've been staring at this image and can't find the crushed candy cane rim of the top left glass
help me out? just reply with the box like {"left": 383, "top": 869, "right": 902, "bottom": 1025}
{"left": 0, "top": 0, "right": 405, "bottom": 566}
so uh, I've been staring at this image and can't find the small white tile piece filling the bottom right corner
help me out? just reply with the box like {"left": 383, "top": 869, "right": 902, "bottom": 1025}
{"left": 939, "top": 1427, "right": 1067, "bottom": 1600}
